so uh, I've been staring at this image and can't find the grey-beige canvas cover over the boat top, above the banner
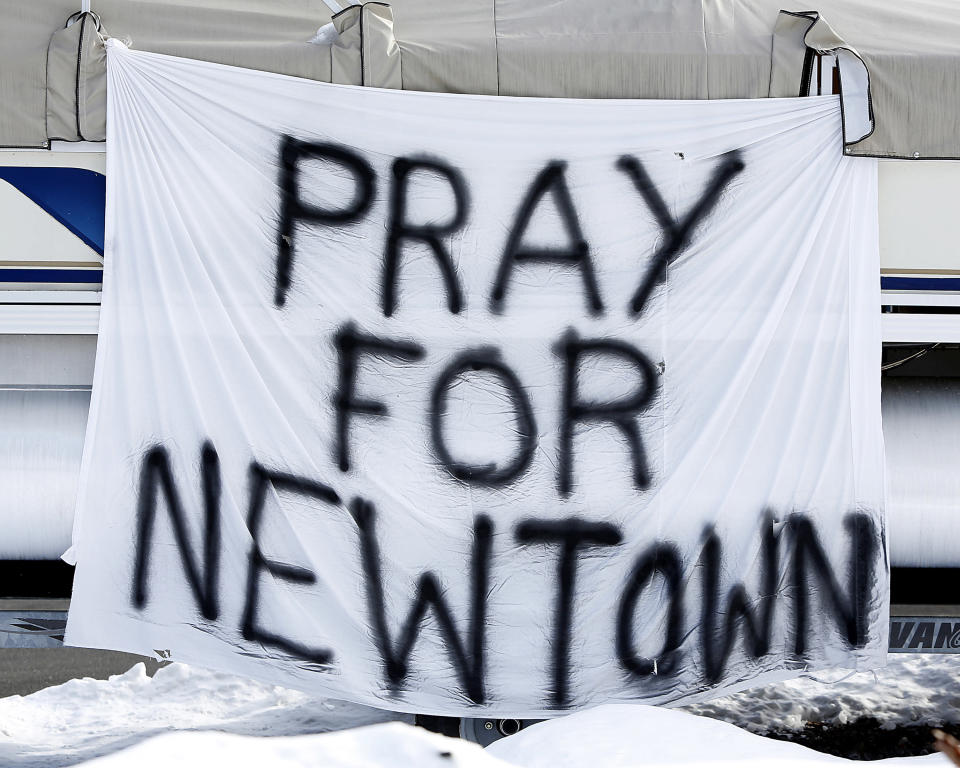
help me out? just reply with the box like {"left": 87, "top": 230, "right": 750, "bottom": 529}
{"left": 0, "top": 0, "right": 960, "bottom": 158}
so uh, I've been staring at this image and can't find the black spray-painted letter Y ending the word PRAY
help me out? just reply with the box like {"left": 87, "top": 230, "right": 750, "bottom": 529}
{"left": 617, "top": 151, "right": 745, "bottom": 315}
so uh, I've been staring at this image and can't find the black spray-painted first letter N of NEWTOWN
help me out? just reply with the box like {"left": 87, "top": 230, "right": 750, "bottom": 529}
{"left": 133, "top": 441, "right": 221, "bottom": 621}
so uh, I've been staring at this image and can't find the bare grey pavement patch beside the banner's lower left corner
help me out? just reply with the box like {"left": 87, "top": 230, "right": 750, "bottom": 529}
{"left": 0, "top": 647, "right": 159, "bottom": 697}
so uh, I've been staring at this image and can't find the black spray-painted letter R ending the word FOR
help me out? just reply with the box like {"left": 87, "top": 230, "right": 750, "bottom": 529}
{"left": 557, "top": 329, "right": 657, "bottom": 496}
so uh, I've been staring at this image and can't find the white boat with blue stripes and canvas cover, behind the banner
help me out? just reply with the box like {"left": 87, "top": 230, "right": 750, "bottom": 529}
{"left": 0, "top": 0, "right": 960, "bottom": 650}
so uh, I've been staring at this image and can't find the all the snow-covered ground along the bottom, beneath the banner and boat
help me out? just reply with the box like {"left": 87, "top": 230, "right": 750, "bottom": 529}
{"left": 0, "top": 654, "right": 960, "bottom": 768}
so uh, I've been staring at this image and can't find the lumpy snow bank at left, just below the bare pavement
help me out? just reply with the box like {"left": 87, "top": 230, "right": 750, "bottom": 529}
{"left": 0, "top": 664, "right": 409, "bottom": 768}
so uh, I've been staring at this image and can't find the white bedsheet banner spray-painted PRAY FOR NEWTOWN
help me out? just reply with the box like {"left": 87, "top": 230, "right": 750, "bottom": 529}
{"left": 67, "top": 43, "right": 887, "bottom": 716}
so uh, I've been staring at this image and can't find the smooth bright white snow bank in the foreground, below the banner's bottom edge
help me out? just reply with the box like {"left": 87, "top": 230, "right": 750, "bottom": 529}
{"left": 71, "top": 704, "right": 942, "bottom": 768}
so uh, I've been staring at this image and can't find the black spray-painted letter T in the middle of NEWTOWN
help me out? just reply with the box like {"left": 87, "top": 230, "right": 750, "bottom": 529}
{"left": 516, "top": 517, "right": 622, "bottom": 707}
